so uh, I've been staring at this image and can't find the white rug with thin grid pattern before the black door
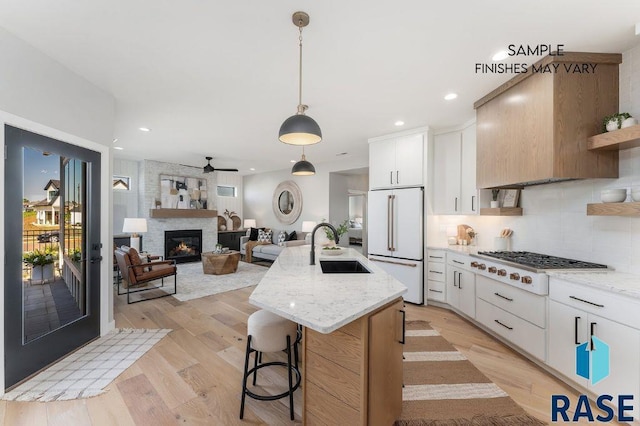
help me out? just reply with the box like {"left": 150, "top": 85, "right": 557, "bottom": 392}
{"left": 2, "top": 329, "right": 171, "bottom": 402}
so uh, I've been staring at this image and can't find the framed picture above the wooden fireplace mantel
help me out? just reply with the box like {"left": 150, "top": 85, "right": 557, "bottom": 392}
{"left": 156, "top": 175, "right": 207, "bottom": 209}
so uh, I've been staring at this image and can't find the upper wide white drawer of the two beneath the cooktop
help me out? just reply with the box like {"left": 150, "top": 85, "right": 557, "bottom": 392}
{"left": 476, "top": 275, "right": 547, "bottom": 328}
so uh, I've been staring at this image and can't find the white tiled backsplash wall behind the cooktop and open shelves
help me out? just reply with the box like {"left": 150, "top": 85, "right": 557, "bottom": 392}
{"left": 427, "top": 40, "right": 640, "bottom": 274}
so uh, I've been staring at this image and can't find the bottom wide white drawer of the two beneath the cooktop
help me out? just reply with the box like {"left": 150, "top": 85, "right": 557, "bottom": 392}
{"left": 476, "top": 299, "right": 547, "bottom": 361}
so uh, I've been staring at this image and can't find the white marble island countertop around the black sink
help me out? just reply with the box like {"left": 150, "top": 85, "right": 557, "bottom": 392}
{"left": 249, "top": 245, "right": 407, "bottom": 334}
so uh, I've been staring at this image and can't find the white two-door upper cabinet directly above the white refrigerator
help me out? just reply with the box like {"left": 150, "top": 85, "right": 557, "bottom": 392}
{"left": 369, "top": 133, "right": 424, "bottom": 189}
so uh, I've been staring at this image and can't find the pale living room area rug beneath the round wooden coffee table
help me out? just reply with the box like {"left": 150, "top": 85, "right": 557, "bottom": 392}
{"left": 173, "top": 262, "right": 268, "bottom": 302}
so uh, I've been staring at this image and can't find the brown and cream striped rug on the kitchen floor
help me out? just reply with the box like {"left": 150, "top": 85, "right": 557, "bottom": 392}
{"left": 396, "top": 321, "right": 545, "bottom": 426}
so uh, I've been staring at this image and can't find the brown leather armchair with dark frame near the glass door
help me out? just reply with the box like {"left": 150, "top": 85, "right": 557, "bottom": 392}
{"left": 114, "top": 246, "right": 178, "bottom": 304}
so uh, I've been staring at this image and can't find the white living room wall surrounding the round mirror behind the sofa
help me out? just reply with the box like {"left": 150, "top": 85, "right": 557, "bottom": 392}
{"left": 243, "top": 156, "right": 369, "bottom": 232}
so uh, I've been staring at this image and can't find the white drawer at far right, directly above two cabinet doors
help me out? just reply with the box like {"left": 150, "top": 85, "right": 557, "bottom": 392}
{"left": 549, "top": 277, "right": 640, "bottom": 329}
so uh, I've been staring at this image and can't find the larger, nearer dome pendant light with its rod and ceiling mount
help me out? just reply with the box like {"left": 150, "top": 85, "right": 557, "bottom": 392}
{"left": 278, "top": 12, "right": 322, "bottom": 145}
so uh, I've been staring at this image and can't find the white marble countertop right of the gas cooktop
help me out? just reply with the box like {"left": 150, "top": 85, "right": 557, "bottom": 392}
{"left": 547, "top": 271, "right": 640, "bottom": 299}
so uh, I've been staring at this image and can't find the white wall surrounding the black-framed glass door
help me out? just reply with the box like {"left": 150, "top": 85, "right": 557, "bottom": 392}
{"left": 0, "top": 28, "right": 115, "bottom": 394}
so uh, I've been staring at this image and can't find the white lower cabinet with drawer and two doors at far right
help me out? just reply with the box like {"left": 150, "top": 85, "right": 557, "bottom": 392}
{"left": 547, "top": 278, "right": 640, "bottom": 420}
